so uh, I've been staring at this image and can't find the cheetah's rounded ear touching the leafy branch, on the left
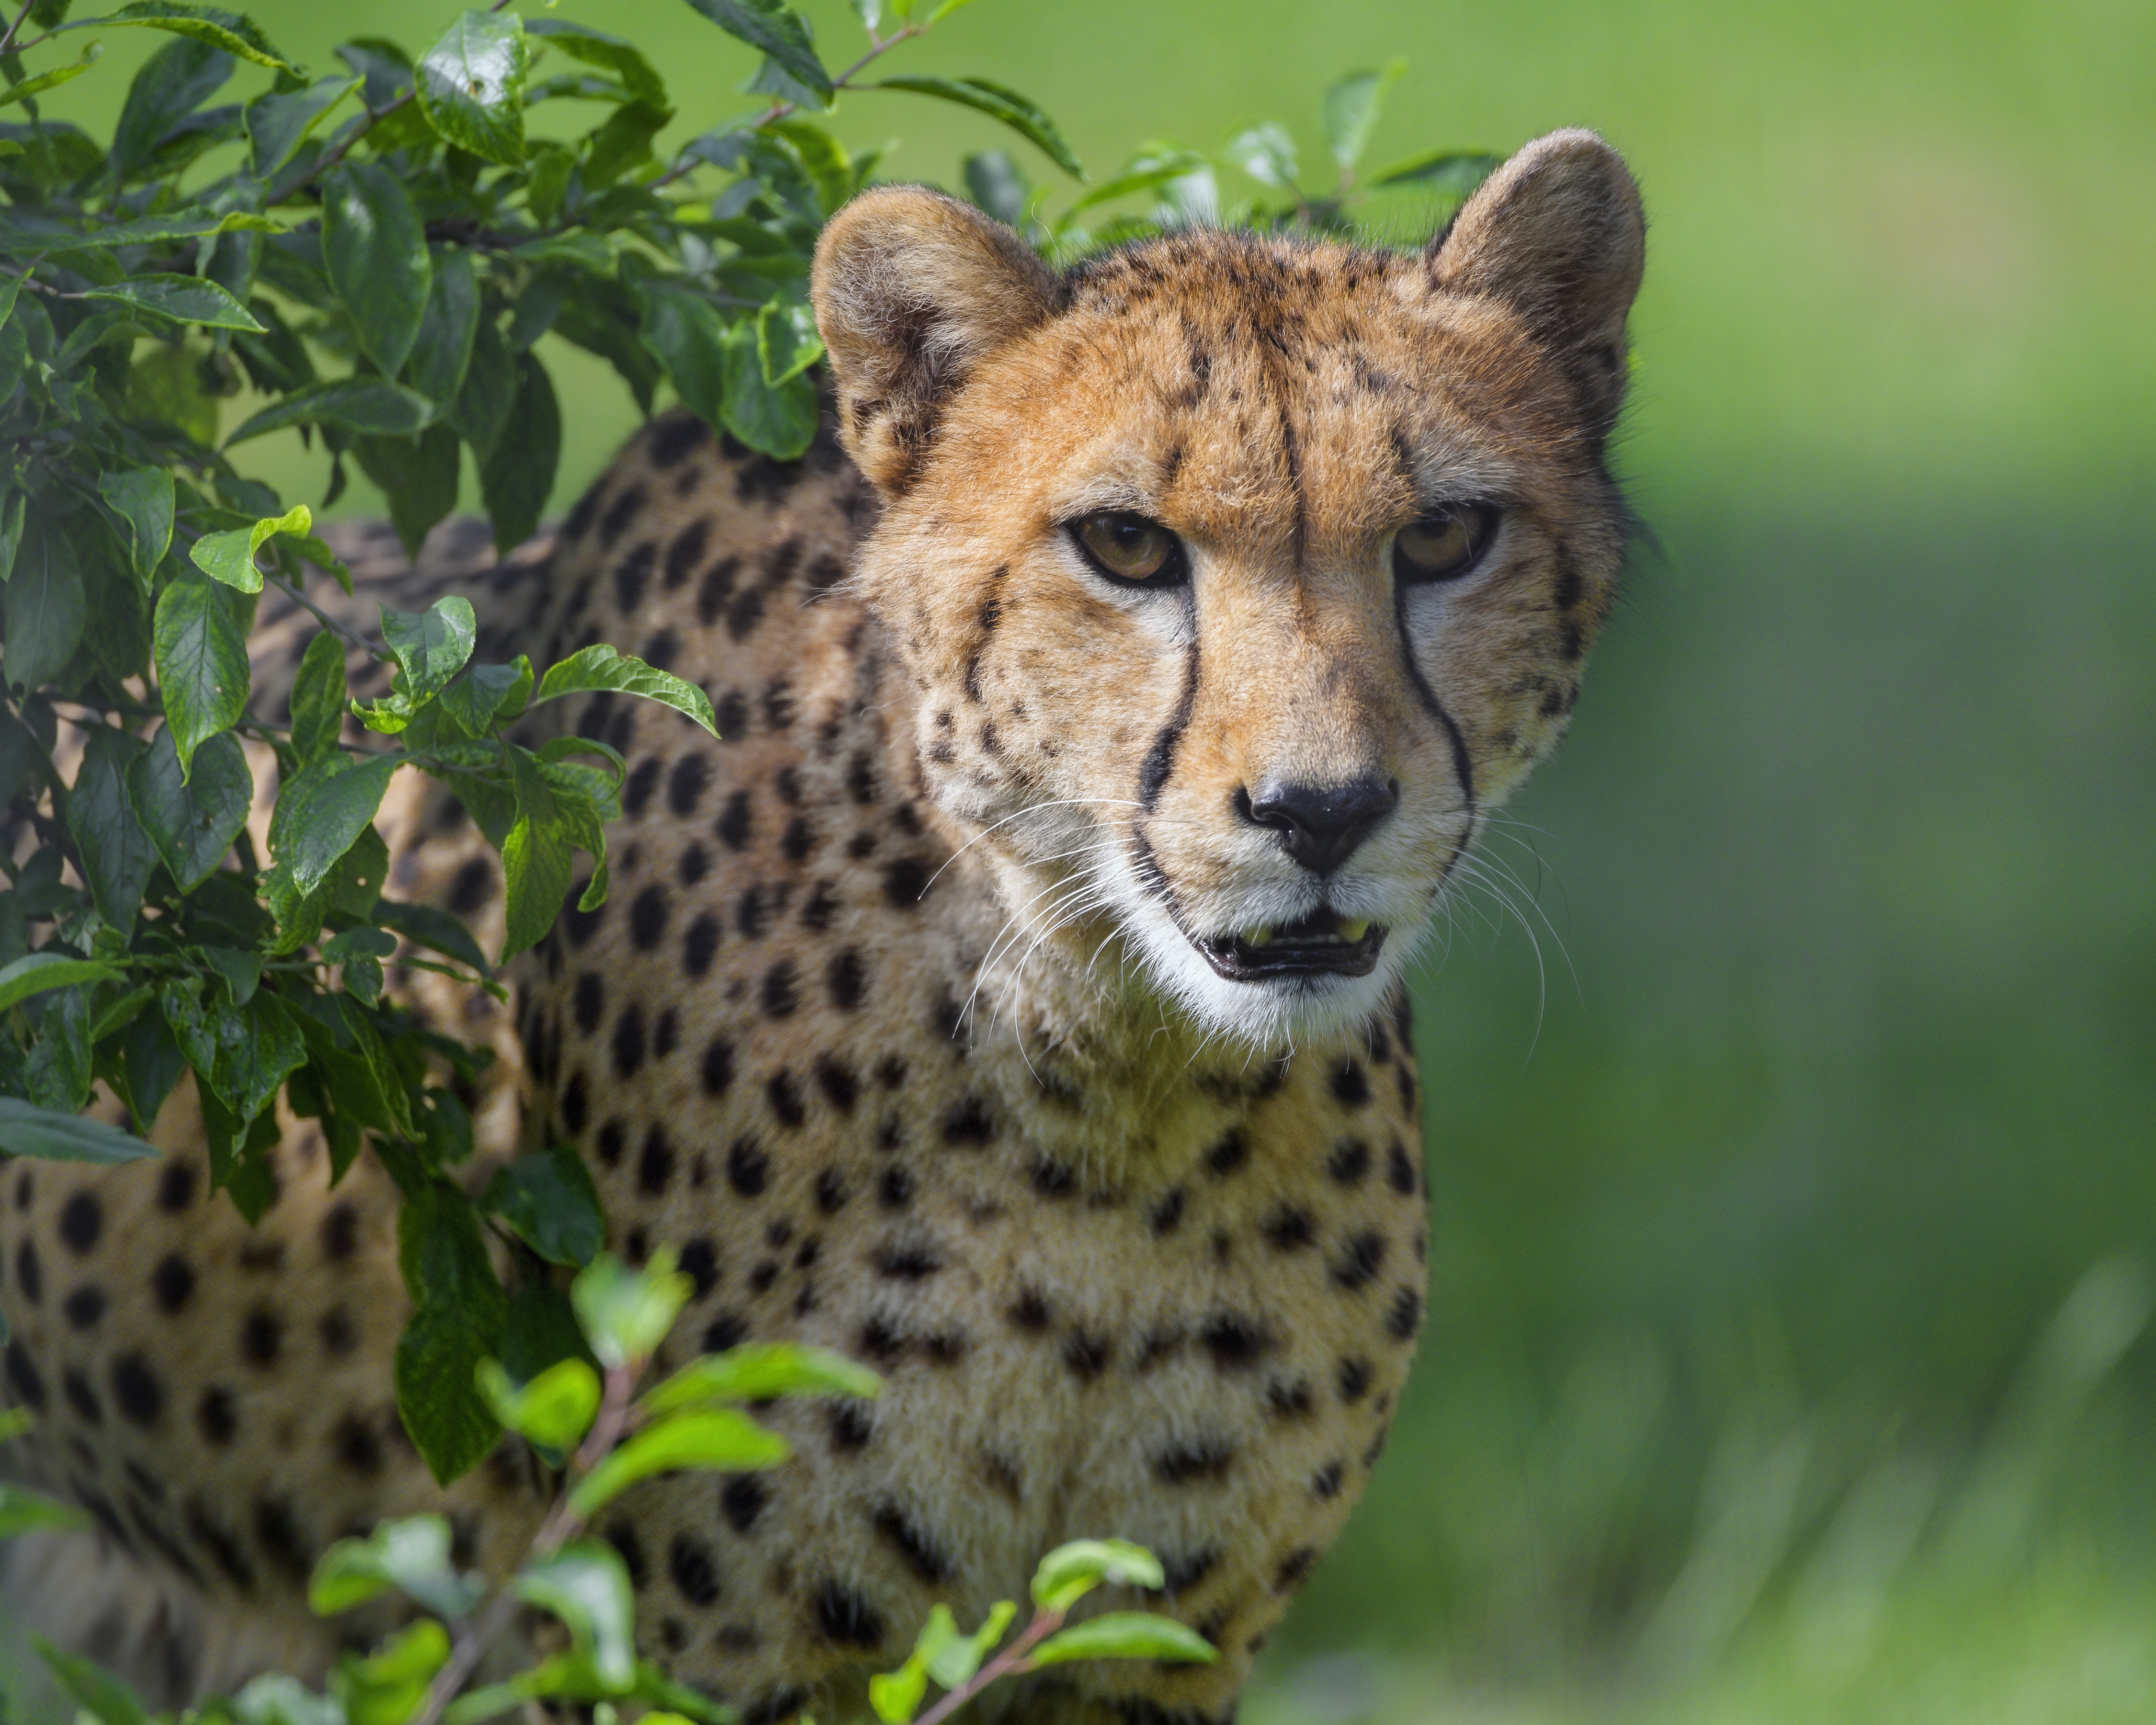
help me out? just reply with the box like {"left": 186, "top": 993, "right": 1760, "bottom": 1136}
{"left": 808, "top": 185, "right": 1056, "bottom": 496}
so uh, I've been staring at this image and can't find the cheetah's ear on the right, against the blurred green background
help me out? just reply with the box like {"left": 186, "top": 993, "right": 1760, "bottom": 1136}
{"left": 1430, "top": 129, "right": 1647, "bottom": 422}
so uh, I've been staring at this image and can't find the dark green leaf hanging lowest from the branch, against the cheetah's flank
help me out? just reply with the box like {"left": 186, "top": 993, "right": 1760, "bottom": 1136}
{"left": 397, "top": 1181, "right": 509, "bottom": 1486}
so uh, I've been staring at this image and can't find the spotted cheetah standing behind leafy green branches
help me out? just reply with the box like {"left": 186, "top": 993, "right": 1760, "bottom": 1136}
{"left": 0, "top": 132, "right": 1645, "bottom": 1725}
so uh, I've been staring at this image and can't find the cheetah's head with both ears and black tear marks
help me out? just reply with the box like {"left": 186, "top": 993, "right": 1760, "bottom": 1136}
{"left": 815, "top": 132, "right": 1643, "bottom": 1048}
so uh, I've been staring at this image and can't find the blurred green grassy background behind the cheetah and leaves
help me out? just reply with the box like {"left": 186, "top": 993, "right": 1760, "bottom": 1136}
{"left": 21, "top": 0, "right": 2156, "bottom": 1725}
